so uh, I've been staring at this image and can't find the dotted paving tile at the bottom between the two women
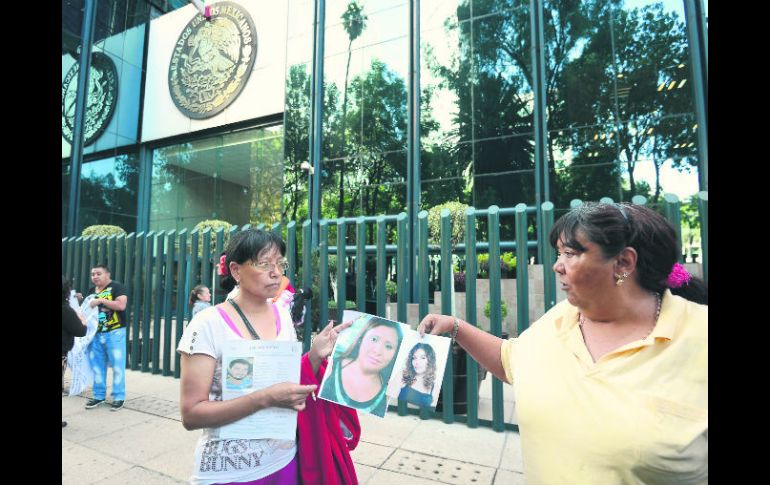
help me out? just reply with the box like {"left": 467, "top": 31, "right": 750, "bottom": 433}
{"left": 382, "top": 450, "right": 495, "bottom": 485}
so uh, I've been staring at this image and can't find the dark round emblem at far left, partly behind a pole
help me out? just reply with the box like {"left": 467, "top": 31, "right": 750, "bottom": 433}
{"left": 61, "top": 52, "right": 118, "bottom": 146}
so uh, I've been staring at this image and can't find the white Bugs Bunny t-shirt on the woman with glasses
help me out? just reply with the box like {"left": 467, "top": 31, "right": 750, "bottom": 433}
{"left": 177, "top": 306, "right": 297, "bottom": 485}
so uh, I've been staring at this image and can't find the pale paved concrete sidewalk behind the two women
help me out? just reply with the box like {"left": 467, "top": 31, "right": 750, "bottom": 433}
{"left": 62, "top": 370, "right": 525, "bottom": 485}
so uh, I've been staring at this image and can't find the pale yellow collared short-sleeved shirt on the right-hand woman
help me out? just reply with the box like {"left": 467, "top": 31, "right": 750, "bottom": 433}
{"left": 501, "top": 290, "right": 708, "bottom": 485}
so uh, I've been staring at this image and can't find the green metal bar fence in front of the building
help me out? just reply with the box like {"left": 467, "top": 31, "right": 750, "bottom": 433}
{"left": 62, "top": 192, "right": 708, "bottom": 431}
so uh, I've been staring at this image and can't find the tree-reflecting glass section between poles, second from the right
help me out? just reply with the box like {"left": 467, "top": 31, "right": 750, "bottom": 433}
{"left": 420, "top": 0, "right": 535, "bottom": 214}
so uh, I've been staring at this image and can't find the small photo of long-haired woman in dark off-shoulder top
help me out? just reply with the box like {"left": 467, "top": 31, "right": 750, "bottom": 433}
{"left": 398, "top": 343, "right": 440, "bottom": 407}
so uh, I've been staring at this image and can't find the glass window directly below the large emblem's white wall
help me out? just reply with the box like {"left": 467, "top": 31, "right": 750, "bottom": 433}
{"left": 149, "top": 126, "right": 284, "bottom": 231}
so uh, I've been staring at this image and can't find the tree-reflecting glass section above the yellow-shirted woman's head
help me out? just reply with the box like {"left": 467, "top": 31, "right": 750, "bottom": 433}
{"left": 544, "top": 0, "right": 698, "bottom": 216}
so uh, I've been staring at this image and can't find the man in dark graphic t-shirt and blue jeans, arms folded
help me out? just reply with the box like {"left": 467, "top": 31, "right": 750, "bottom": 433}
{"left": 86, "top": 264, "right": 128, "bottom": 411}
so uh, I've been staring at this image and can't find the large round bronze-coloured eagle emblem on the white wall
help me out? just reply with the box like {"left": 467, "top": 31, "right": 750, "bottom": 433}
{"left": 168, "top": 2, "right": 257, "bottom": 119}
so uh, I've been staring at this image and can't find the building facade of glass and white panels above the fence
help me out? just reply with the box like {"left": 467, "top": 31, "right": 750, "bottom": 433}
{"left": 62, "top": 0, "right": 708, "bottom": 242}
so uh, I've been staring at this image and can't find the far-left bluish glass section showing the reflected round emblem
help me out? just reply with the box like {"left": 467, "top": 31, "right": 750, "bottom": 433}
{"left": 62, "top": 0, "right": 150, "bottom": 236}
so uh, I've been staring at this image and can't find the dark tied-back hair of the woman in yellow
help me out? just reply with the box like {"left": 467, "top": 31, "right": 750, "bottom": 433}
{"left": 549, "top": 202, "right": 708, "bottom": 304}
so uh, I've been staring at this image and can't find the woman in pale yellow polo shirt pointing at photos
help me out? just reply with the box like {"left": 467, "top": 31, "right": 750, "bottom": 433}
{"left": 418, "top": 203, "right": 708, "bottom": 485}
